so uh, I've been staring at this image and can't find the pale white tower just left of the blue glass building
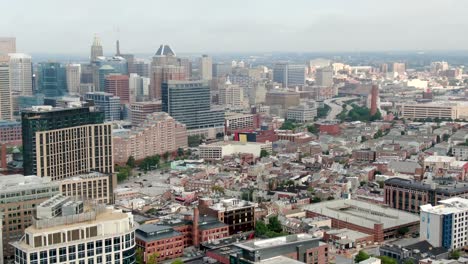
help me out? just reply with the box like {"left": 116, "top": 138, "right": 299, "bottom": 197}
{"left": 8, "top": 53, "right": 32, "bottom": 95}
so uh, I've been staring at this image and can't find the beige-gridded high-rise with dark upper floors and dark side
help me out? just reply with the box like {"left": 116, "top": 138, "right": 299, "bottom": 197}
{"left": 21, "top": 106, "right": 114, "bottom": 180}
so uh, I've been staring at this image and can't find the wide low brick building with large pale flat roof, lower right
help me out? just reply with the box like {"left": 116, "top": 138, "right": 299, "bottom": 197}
{"left": 304, "top": 200, "right": 419, "bottom": 242}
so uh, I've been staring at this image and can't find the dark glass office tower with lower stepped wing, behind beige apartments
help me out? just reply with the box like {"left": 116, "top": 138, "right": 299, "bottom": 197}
{"left": 162, "top": 81, "right": 224, "bottom": 130}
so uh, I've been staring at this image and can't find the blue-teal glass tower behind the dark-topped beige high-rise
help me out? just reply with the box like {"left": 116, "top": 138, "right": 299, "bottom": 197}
{"left": 38, "top": 62, "right": 68, "bottom": 97}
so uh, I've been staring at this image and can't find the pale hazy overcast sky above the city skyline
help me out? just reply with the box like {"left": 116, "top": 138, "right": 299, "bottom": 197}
{"left": 0, "top": 0, "right": 468, "bottom": 54}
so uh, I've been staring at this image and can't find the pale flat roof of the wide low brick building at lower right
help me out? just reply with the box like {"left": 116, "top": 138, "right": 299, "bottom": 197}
{"left": 303, "top": 200, "right": 419, "bottom": 229}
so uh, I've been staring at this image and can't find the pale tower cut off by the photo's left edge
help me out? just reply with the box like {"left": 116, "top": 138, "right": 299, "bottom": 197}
{"left": 0, "top": 57, "right": 13, "bottom": 120}
